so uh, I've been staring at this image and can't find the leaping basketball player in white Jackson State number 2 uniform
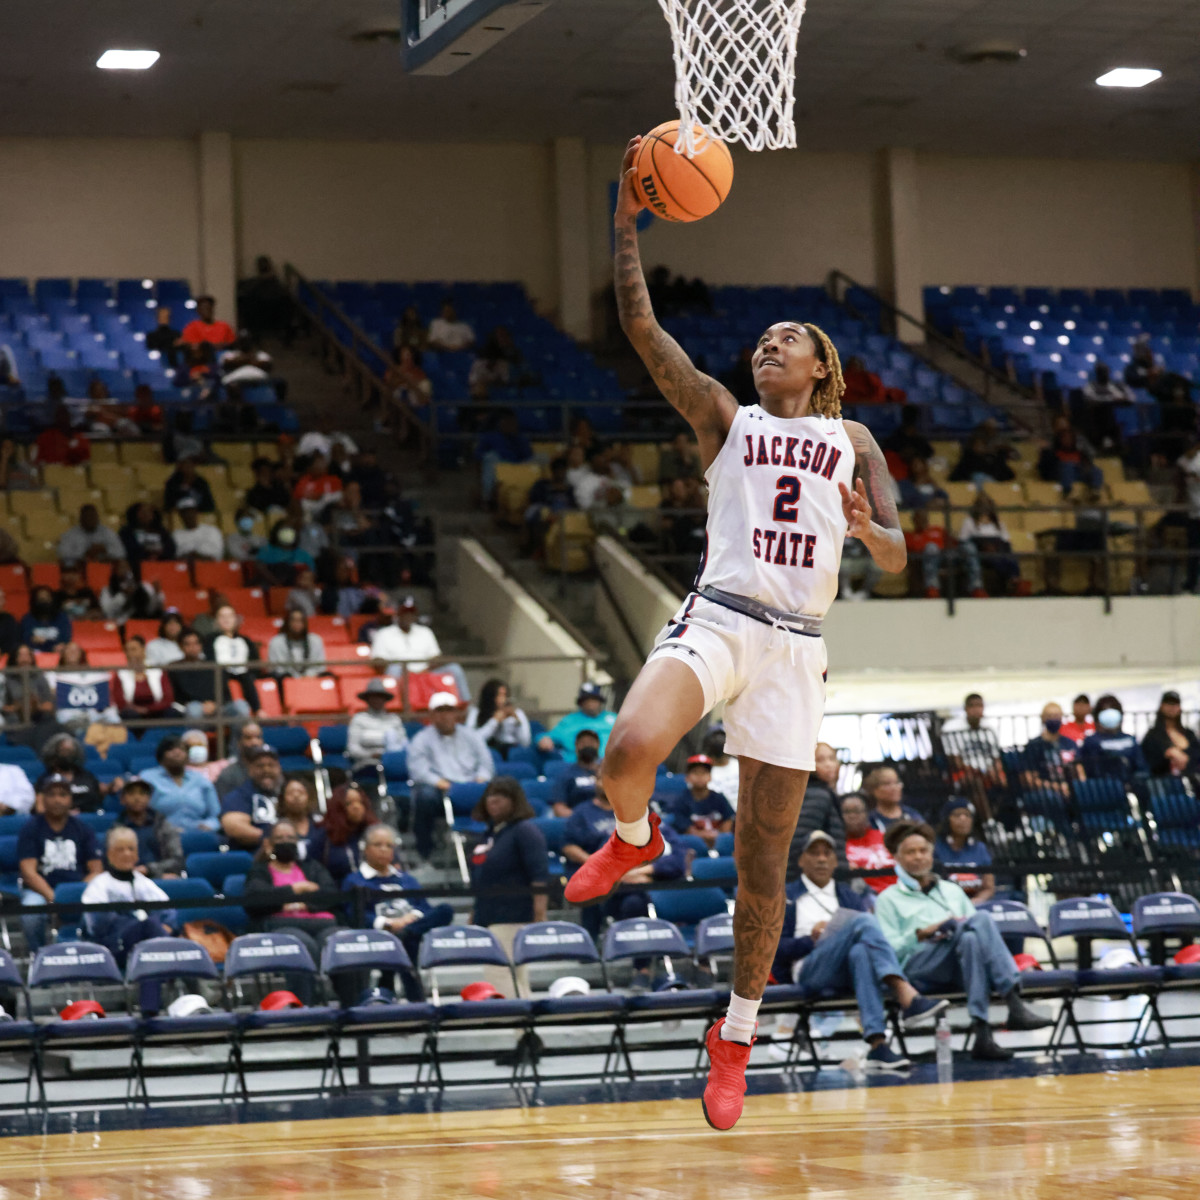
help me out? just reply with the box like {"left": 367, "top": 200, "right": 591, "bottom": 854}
{"left": 566, "top": 138, "right": 906, "bottom": 1129}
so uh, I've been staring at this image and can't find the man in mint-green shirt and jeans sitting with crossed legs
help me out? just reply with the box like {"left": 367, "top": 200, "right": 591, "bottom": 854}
{"left": 875, "top": 821, "right": 1055, "bottom": 1061}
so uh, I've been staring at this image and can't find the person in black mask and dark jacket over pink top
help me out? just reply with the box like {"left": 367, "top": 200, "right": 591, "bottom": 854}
{"left": 242, "top": 821, "right": 343, "bottom": 1004}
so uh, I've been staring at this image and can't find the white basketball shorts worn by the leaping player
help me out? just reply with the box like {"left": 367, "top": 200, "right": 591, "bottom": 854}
{"left": 649, "top": 592, "right": 829, "bottom": 770}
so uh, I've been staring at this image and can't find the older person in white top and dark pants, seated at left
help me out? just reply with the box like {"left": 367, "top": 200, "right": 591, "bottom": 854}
{"left": 83, "top": 826, "right": 179, "bottom": 1015}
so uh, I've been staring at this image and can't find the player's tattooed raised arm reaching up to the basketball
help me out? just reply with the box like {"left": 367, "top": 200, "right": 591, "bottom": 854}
{"left": 613, "top": 138, "right": 738, "bottom": 467}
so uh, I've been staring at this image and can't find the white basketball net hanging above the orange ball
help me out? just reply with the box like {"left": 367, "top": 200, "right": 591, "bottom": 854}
{"left": 659, "top": 0, "right": 806, "bottom": 156}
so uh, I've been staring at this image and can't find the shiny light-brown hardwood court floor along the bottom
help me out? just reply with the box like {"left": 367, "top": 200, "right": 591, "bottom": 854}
{"left": 0, "top": 1068, "right": 1200, "bottom": 1200}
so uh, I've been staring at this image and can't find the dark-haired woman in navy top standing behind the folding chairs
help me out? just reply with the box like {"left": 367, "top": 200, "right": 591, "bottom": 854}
{"left": 470, "top": 775, "right": 550, "bottom": 996}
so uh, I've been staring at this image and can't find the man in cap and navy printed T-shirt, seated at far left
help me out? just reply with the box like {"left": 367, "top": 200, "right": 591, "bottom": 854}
{"left": 17, "top": 775, "right": 102, "bottom": 950}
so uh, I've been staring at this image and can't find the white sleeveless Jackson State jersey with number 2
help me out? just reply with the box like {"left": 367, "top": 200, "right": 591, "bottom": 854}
{"left": 696, "top": 404, "right": 854, "bottom": 617}
